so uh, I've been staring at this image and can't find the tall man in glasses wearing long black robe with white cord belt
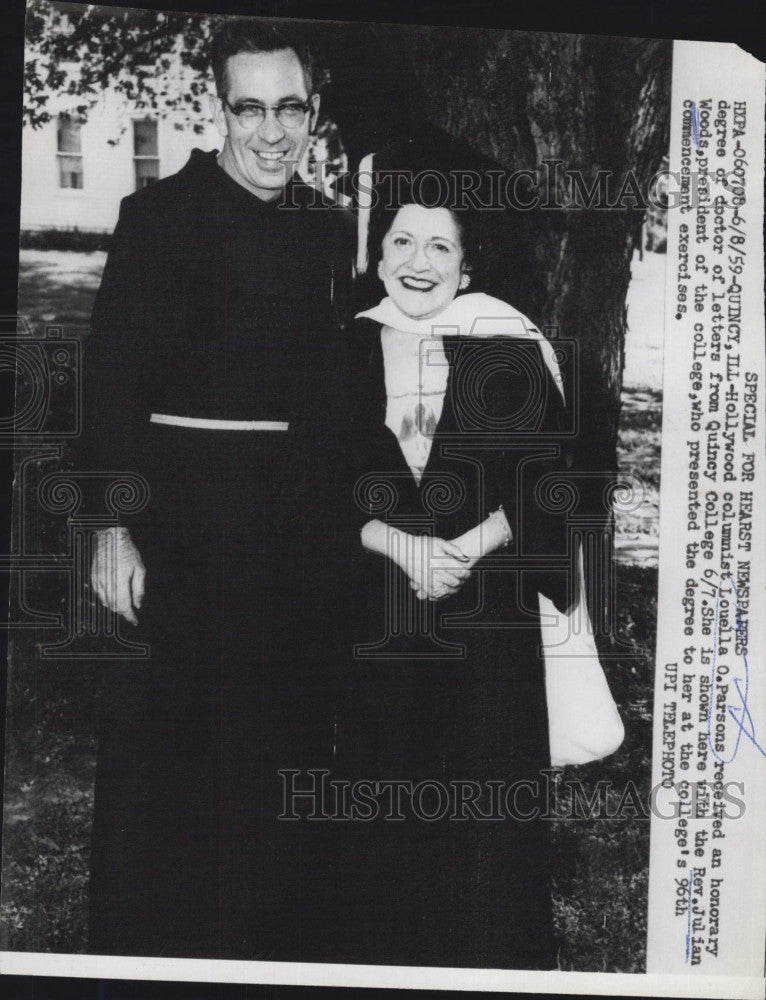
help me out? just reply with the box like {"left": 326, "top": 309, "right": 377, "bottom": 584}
{"left": 83, "top": 20, "right": 353, "bottom": 960}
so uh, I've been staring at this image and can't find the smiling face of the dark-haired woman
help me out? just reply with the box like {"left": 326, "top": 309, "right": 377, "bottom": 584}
{"left": 378, "top": 205, "right": 470, "bottom": 319}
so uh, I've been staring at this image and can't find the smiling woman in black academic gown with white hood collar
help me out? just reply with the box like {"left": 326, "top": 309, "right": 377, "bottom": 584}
{"left": 326, "top": 193, "right": 567, "bottom": 968}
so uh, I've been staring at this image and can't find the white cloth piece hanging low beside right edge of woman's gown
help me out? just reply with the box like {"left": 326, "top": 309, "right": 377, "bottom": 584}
{"left": 538, "top": 550, "right": 625, "bottom": 767}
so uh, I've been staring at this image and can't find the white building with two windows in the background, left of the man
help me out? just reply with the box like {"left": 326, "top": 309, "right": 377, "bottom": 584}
{"left": 20, "top": 85, "right": 222, "bottom": 232}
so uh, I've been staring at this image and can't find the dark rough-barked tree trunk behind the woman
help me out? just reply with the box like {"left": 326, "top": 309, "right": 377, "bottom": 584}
{"left": 411, "top": 28, "right": 671, "bottom": 480}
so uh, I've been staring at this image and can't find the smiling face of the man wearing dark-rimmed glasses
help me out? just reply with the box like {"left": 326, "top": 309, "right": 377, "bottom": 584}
{"left": 213, "top": 49, "right": 319, "bottom": 201}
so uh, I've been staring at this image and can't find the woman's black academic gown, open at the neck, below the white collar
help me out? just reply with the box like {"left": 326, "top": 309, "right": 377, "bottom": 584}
{"left": 320, "top": 319, "right": 568, "bottom": 968}
